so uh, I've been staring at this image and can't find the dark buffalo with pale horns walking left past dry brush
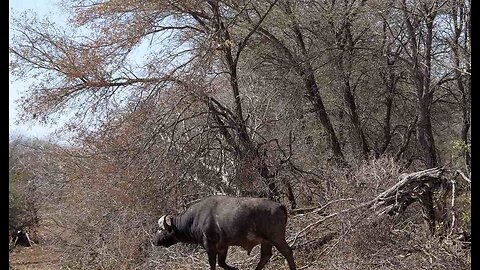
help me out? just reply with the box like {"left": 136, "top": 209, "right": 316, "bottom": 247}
{"left": 153, "top": 196, "right": 296, "bottom": 270}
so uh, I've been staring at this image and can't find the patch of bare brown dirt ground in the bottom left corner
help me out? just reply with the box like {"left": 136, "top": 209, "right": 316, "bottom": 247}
{"left": 9, "top": 245, "right": 62, "bottom": 270}
